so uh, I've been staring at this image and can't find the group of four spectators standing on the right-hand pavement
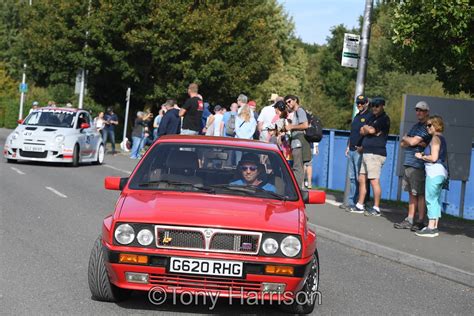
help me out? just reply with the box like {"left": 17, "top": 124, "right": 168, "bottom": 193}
{"left": 341, "top": 95, "right": 449, "bottom": 237}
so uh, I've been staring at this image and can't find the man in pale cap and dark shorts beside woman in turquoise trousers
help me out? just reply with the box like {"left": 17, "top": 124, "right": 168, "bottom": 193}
{"left": 393, "top": 101, "right": 431, "bottom": 231}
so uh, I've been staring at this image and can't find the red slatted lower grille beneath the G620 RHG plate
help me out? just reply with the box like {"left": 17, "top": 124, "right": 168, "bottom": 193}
{"left": 150, "top": 274, "right": 262, "bottom": 296}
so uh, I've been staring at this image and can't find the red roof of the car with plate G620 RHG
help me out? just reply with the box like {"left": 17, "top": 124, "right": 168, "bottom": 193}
{"left": 157, "top": 135, "right": 280, "bottom": 151}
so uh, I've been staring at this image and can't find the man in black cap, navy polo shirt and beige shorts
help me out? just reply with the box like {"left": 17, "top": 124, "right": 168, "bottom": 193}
{"left": 351, "top": 98, "right": 390, "bottom": 216}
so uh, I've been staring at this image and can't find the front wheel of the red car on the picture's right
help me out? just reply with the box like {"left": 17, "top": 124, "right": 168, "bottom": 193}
{"left": 280, "top": 253, "right": 320, "bottom": 315}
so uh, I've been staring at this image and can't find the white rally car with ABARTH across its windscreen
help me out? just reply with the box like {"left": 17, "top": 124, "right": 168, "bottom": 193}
{"left": 3, "top": 107, "right": 105, "bottom": 166}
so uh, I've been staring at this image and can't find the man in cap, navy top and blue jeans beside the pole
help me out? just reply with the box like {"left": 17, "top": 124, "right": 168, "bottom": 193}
{"left": 340, "top": 95, "right": 372, "bottom": 210}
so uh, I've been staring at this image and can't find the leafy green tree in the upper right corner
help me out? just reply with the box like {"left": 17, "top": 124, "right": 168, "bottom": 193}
{"left": 392, "top": 0, "right": 474, "bottom": 95}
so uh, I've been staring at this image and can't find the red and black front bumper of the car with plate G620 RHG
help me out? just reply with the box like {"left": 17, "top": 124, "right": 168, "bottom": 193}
{"left": 103, "top": 246, "right": 311, "bottom": 300}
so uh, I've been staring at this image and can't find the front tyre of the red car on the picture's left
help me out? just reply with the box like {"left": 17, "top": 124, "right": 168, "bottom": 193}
{"left": 87, "top": 236, "right": 131, "bottom": 302}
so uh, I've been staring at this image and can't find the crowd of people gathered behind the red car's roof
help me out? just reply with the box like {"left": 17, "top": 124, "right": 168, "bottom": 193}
{"left": 116, "top": 83, "right": 319, "bottom": 188}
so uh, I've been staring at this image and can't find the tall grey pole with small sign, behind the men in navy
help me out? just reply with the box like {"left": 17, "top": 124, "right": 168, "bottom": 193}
{"left": 343, "top": 0, "right": 374, "bottom": 203}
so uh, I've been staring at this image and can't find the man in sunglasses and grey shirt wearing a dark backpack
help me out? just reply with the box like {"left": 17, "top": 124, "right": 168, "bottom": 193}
{"left": 284, "top": 95, "right": 311, "bottom": 188}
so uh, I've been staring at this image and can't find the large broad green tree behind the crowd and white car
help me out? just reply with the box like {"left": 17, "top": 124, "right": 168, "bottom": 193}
{"left": 19, "top": 0, "right": 292, "bottom": 107}
